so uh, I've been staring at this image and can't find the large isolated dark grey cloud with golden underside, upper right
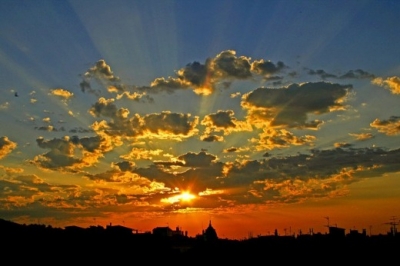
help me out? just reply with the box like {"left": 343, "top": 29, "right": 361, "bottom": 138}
{"left": 242, "top": 82, "right": 352, "bottom": 129}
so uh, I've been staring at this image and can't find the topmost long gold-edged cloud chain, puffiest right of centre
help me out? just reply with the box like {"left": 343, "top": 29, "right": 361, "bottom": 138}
{"left": 80, "top": 50, "right": 288, "bottom": 99}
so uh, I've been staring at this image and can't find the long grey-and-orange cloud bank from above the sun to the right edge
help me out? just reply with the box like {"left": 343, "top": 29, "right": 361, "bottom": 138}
{"left": 128, "top": 145, "right": 400, "bottom": 207}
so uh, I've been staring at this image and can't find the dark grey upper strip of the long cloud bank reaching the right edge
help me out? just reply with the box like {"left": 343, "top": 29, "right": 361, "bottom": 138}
{"left": 226, "top": 148, "right": 400, "bottom": 181}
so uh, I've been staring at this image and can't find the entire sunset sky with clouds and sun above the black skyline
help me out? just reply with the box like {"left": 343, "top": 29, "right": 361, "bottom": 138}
{"left": 0, "top": 0, "right": 400, "bottom": 239}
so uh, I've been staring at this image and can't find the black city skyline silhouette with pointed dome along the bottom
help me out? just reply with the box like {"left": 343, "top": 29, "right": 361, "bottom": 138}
{"left": 0, "top": 219, "right": 400, "bottom": 262}
